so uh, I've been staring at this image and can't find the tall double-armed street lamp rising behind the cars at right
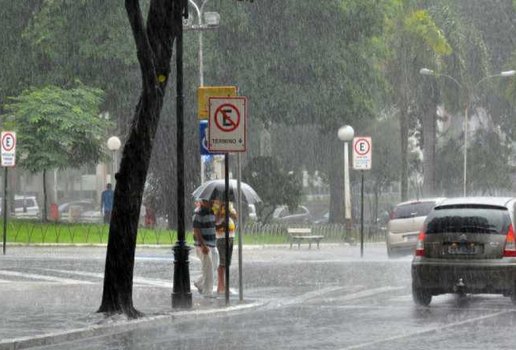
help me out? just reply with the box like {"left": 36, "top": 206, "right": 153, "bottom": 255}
{"left": 419, "top": 68, "right": 516, "bottom": 197}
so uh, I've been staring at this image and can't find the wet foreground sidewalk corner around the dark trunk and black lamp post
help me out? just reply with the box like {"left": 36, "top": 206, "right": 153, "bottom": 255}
{"left": 0, "top": 283, "right": 260, "bottom": 350}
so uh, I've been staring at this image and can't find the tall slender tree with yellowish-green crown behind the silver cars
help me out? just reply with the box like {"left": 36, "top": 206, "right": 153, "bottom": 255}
{"left": 385, "top": 0, "right": 451, "bottom": 200}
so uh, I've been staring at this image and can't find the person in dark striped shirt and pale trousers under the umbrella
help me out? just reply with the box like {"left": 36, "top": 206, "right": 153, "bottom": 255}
{"left": 192, "top": 199, "right": 216, "bottom": 297}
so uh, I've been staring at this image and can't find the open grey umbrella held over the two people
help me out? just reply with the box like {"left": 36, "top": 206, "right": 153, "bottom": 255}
{"left": 192, "top": 179, "right": 261, "bottom": 204}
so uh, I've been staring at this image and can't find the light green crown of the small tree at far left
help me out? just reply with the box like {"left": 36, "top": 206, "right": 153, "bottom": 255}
{"left": 2, "top": 84, "right": 111, "bottom": 173}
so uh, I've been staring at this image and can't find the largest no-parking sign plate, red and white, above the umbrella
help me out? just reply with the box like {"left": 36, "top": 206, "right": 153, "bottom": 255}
{"left": 208, "top": 96, "right": 247, "bottom": 152}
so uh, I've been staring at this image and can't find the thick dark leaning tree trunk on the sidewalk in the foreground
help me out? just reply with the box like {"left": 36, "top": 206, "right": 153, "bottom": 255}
{"left": 98, "top": 0, "right": 179, "bottom": 318}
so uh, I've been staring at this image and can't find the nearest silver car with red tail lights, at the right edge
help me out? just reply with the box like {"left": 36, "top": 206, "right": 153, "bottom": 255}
{"left": 412, "top": 197, "right": 516, "bottom": 305}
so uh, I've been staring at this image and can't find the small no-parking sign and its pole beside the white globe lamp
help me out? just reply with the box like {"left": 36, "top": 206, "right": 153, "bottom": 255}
{"left": 353, "top": 136, "right": 373, "bottom": 257}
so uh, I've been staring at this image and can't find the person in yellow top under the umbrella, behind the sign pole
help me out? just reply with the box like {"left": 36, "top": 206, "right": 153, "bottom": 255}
{"left": 215, "top": 202, "right": 237, "bottom": 294}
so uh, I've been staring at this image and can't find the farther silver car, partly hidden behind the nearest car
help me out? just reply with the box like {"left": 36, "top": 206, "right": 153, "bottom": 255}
{"left": 386, "top": 198, "right": 444, "bottom": 258}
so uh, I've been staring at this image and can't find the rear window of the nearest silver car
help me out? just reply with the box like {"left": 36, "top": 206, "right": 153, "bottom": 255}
{"left": 425, "top": 206, "right": 510, "bottom": 234}
